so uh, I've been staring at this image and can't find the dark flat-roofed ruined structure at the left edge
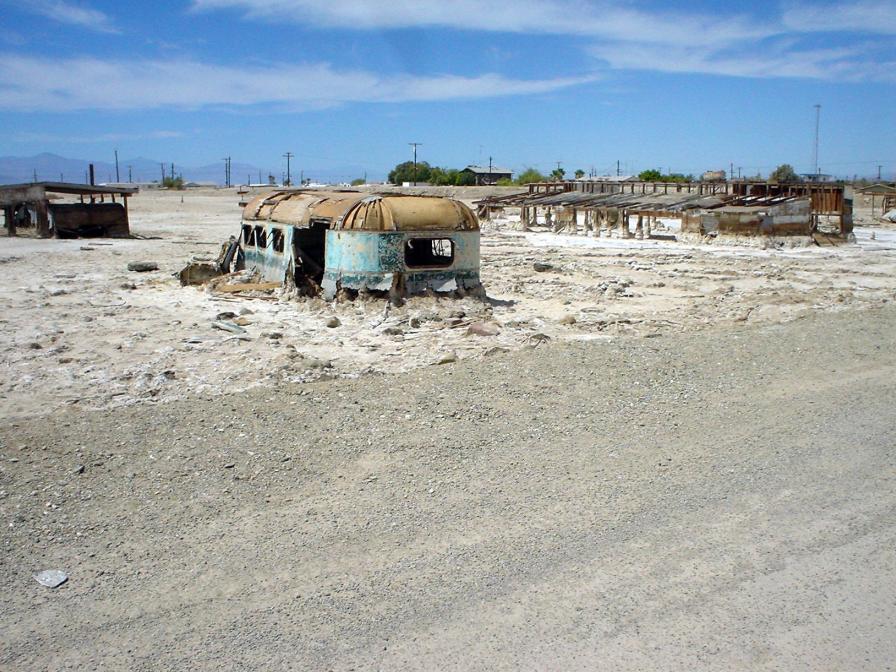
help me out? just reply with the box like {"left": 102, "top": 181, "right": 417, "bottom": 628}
{"left": 0, "top": 182, "right": 138, "bottom": 238}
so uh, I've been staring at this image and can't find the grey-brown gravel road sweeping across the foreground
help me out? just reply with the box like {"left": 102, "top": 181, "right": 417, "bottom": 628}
{"left": 0, "top": 303, "right": 896, "bottom": 670}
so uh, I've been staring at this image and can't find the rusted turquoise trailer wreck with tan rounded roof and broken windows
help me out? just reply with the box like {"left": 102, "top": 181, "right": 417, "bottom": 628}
{"left": 237, "top": 191, "right": 482, "bottom": 300}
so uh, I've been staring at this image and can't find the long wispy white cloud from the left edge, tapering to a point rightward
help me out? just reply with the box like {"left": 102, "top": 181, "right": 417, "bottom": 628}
{"left": 0, "top": 54, "right": 596, "bottom": 111}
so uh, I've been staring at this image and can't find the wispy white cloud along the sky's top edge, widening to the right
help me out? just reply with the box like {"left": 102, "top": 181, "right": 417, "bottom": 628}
{"left": 193, "top": 0, "right": 896, "bottom": 81}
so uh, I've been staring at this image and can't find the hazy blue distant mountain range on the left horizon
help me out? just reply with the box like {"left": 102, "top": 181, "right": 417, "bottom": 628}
{"left": 0, "top": 153, "right": 376, "bottom": 185}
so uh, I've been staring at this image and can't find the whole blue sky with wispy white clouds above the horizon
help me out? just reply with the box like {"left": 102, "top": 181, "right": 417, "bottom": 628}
{"left": 0, "top": 0, "right": 896, "bottom": 179}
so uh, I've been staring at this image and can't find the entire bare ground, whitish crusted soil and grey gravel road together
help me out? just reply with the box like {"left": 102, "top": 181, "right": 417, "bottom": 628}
{"left": 0, "top": 192, "right": 896, "bottom": 671}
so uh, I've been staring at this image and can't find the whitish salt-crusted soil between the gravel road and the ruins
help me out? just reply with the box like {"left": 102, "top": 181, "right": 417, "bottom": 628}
{"left": 0, "top": 189, "right": 896, "bottom": 418}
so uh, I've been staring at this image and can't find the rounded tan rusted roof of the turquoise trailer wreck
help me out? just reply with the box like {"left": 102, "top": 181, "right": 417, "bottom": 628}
{"left": 243, "top": 191, "right": 479, "bottom": 231}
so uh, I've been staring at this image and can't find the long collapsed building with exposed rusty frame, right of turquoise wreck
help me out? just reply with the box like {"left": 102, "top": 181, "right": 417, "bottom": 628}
{"left": 477, "top": 180, "right": 852, "bottom": 243}
